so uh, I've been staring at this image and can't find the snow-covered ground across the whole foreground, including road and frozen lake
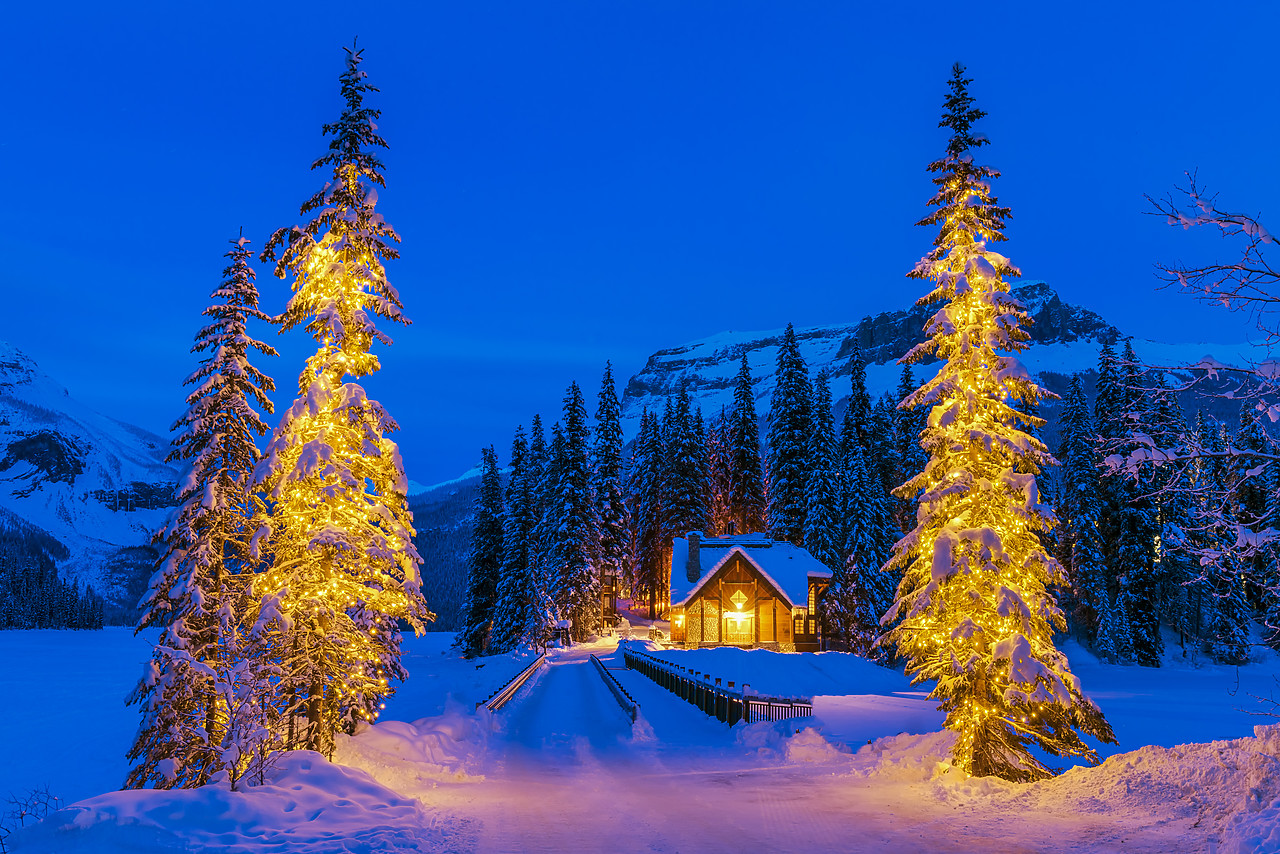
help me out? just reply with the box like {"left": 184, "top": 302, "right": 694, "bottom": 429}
{"left": 0, "top": 630, "right": 1280, "bottom": 854}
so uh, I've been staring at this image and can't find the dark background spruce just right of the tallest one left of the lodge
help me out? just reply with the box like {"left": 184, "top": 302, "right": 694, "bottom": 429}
{"left": 627, "top": 410, "right": 671, "bottom": 620}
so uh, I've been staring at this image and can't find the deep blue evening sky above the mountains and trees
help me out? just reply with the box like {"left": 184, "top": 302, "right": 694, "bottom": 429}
{"left": 0, "top": 0, "right": 1280, "bottom": 483}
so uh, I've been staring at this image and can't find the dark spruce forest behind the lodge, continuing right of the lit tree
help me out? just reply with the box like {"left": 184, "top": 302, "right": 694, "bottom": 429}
{"left": 460, "top": 326, "right": 1280, "bottom": 666}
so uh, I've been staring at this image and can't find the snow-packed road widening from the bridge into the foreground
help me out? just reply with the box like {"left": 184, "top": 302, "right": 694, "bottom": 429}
{"left": 381, "top": 649, "right": 1187, "bottom": 854}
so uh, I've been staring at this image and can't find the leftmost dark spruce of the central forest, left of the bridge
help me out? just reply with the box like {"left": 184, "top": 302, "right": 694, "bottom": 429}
{"left": 457, "top": 446, "right": 503, "bottom": 658}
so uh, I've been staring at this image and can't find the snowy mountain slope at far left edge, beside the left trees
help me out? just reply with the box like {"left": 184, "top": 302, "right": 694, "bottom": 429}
{"left": 0, "top": 342, "right": 178, "bottom": 620}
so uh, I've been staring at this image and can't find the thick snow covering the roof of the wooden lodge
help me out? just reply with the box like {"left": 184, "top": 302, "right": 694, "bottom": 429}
{"left": 671, "top": 534, "right": 831, "bottom": 608}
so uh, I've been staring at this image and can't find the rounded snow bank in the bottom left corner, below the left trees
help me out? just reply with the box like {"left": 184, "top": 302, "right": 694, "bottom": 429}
{"left": 13, "top": 750, "right": 458, "bottom": 854}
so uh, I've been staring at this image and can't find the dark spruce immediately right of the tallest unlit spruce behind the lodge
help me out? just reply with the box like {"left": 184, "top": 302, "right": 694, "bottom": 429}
{"left": 804, "top": 371, "right": 845, "bottom": 570}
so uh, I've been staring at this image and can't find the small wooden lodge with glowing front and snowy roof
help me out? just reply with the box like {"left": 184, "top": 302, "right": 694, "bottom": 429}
{"left": 669, "top": 531, "right": 831, "bottom": 652}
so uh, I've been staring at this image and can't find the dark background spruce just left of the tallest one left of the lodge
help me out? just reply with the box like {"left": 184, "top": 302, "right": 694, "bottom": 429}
{"left": 548, "top": 383, "right": 602, "bottom": 641}
